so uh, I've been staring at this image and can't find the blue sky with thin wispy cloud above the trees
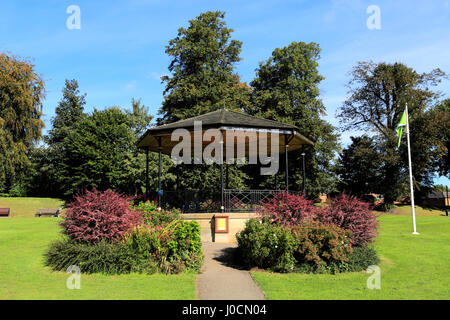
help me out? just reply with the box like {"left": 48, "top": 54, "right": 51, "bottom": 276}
{"left": 0, "top": 0, "right": 450, "bottom": 184}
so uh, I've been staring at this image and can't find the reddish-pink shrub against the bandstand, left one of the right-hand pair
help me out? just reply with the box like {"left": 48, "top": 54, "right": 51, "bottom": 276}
{"left": 258, "top": 192, "right": 318, "bottom": 227}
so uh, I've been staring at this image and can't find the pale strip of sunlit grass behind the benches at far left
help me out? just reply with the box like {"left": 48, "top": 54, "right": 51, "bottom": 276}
{"left": 0, "top": 197, "right": 64, "bottom": 217}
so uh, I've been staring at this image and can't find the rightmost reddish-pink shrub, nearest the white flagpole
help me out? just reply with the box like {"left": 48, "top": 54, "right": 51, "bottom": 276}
{"left": 318, "top": 194, "right": 378, "bottom": 247}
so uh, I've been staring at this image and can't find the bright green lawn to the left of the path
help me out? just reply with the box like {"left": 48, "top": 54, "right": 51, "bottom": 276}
{"left": 0, "top": 218, "right": 196, "bottom": 300}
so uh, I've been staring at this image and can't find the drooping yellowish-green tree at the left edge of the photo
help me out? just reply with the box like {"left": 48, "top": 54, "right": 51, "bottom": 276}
{"left": 0, "top": 53, "right": 45, "bottom": 191}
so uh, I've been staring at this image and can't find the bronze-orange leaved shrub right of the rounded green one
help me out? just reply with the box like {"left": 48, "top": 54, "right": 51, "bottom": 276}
{"left": 291, "top": 220, "right": 353, "bottom": 273}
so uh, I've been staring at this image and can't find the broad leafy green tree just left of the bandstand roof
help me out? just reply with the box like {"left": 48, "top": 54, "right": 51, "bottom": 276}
{"left": 61, "top": 108, "right": 134, "bottom": 197}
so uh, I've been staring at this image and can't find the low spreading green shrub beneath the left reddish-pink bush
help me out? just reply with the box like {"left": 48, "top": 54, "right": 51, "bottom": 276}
{"left": 45, "top": 239, "right": 157, "bottom": 274}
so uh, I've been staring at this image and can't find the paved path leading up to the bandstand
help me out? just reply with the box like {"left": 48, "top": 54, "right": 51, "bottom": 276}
{"left": 197, "top": 242, "right": 264, "bottom": 300}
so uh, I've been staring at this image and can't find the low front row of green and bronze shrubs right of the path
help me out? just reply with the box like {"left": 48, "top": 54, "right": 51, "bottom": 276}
{"left": 236, "top": 219, "right": 379, "bottom": 273}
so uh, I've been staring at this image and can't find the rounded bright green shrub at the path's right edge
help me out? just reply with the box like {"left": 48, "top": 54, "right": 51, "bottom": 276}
{"left": 236, "top": 219, "right": 295, "bottom": 272}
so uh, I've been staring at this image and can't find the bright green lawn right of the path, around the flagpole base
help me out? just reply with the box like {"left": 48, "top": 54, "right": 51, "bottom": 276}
{"left": 252, "top": 215, "right": 450, "bottom": 300}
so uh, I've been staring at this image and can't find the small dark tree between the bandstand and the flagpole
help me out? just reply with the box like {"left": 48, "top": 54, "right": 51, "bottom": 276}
{"left": 337, "top": 135, "right": 382, "bottom": 197}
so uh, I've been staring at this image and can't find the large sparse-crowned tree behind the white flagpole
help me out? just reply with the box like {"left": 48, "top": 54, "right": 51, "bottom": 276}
{"left": 338, "top": 62, "right": 445, "bottom": 205}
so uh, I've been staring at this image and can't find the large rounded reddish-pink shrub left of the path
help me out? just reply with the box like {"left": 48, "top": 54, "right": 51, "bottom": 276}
{"left": 61, "top": 188, "right": 142, "bottom": 243}
